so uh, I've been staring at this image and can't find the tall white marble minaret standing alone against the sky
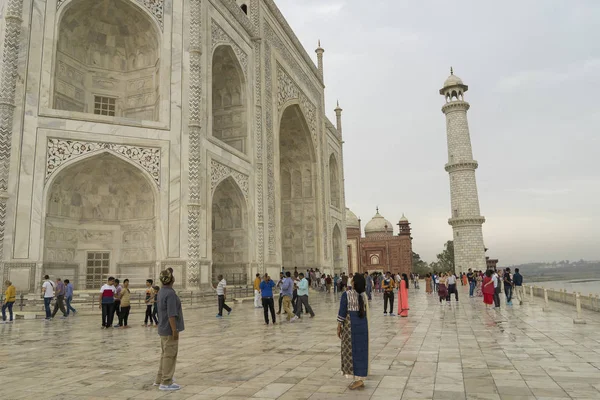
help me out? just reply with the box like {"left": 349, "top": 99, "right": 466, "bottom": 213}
{"left": 440, "top": 68, "right": 486, "bottom": 273}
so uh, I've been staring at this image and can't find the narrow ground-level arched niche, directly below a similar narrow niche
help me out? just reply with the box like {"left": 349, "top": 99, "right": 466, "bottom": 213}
{"left": 212, "top": 177, "right": 249, "bottom": 282}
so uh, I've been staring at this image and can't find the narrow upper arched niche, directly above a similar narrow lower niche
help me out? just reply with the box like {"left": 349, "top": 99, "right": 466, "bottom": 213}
{"left": 212, "top": 45, "right": 248, "bottom": 153}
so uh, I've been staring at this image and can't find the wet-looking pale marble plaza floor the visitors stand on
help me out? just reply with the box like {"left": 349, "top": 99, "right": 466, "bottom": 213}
{"left": 0, "top": 288, "right": 600, "bottom": 400}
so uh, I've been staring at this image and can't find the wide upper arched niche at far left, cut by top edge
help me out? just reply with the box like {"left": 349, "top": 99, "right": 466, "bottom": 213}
{"left": 53, "top": 0, "right": 161, "bottom": 121}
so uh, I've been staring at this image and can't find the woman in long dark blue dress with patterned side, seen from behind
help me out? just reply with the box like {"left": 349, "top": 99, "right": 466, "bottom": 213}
{"left": 337, "top": 273, "right": 369, "bottom": 390}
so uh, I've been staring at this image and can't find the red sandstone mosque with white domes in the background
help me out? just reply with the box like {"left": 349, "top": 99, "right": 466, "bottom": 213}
{"left": 346, "top": 208, "right": 412, "bottom": 274}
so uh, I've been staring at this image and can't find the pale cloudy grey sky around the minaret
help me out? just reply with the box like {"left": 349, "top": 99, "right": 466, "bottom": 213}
{"left": 276, "top": 0, "right": 600, "bottom": 265}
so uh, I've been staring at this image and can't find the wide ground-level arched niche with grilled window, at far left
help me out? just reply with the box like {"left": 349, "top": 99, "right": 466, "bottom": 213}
{"left": 43, "top": 153, "right": 157, "bottom": 289}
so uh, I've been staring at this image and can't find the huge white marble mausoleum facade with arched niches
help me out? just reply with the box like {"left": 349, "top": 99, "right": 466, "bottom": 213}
{"left": 0, "top": 0, "right": 347, "bottom": 292}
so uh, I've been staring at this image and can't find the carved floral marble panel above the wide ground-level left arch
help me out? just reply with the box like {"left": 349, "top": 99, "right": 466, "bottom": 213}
{"left": 46, "top": 138, "right": 160, "bottom": 187}
